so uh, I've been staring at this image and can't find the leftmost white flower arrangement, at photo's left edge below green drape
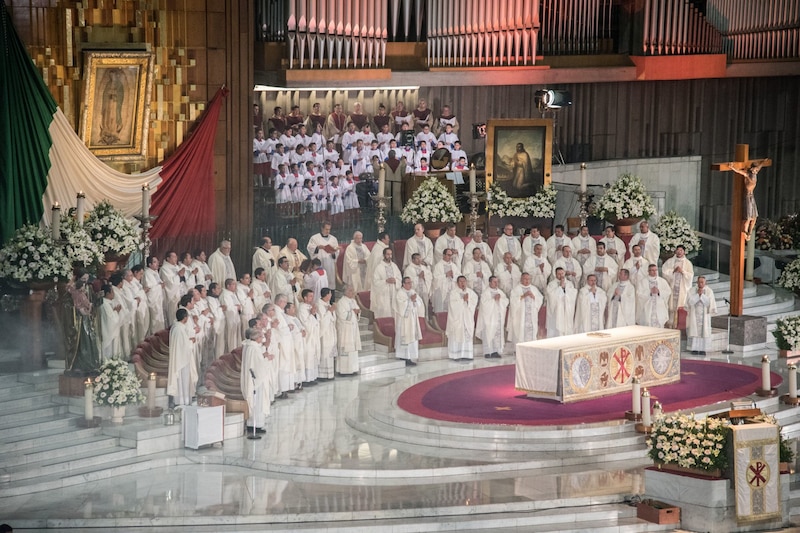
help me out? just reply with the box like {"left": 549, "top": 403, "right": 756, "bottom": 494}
{"left": 0, "top": 224, "right": 72, "bottom": 283}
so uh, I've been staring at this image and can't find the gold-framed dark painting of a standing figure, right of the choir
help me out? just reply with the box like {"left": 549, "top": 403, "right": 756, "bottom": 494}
{"left": 486, "top": 118, "right": 553, "bottom": 198}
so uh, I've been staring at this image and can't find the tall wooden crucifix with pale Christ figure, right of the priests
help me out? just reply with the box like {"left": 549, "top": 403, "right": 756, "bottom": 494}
{"left": 711, "top": 144, "right": 772, "bottom": 316}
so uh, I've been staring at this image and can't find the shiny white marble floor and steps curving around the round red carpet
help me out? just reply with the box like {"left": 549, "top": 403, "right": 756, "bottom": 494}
{"left": 0, "top": 342, "right": 796, "bottom": 531}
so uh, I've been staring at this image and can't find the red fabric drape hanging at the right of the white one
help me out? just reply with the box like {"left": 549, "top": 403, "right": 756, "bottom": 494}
{"left": 150, "top": 87, "right": 229, "bottom": 241}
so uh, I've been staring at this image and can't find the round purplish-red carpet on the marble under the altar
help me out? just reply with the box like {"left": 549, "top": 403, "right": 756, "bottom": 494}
{"left": 397, "top": 360, "right": 782, "bottom": 426}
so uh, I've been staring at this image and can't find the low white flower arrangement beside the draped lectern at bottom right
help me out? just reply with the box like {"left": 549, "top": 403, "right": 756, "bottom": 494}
{"left": 647, "top": 415, "right": 730, "bottom": 470}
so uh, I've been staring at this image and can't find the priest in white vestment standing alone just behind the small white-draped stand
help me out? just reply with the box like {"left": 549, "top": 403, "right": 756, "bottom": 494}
{"left": 167, "top": 309, "right": 198, "bottom": 405}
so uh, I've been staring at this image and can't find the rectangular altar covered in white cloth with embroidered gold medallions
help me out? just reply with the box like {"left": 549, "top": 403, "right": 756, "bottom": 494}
{"left": 516, "top": 326, "right": 681, "bottom": 403}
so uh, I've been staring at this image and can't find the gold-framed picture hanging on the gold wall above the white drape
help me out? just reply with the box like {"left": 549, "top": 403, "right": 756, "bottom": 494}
{"left": 81, "top": 51, "right": 155, "bottom": 161}
